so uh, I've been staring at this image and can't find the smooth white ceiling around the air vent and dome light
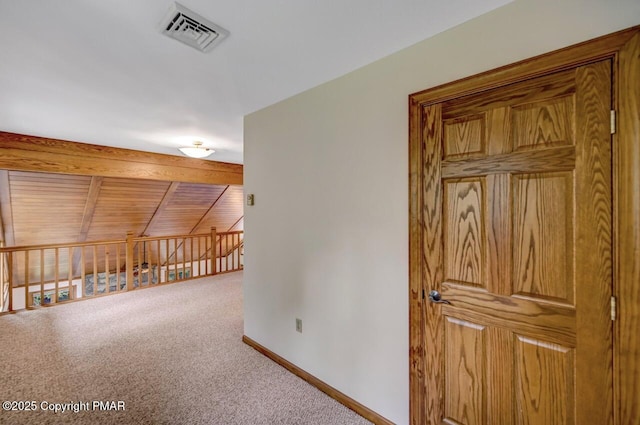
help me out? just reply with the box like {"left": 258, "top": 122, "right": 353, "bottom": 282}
{"left": 0, "top": 0, "right": 511, "bottom": 163}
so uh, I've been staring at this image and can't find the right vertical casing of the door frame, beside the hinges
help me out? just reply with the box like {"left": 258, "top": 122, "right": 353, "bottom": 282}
{"left": 614, "top": 32, "right": 640, "bottom": 425}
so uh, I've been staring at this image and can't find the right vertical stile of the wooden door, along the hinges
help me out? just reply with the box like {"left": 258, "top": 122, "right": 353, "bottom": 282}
{"left": 575, "top": 61, "right": 614, "bottom": 424}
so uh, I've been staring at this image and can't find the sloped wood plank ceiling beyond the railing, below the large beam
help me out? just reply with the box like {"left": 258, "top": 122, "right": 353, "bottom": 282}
{"left": 0, "top": 170, "right": 243, "bottom": 246}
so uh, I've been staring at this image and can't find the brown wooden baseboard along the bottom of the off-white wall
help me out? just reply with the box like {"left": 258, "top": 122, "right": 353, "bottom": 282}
{"left": 242, "top": 335, "right": 393, "bottom": 425}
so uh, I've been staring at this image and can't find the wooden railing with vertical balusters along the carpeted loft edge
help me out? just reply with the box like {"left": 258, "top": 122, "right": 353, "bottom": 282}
{"left": 0, "top": 228, "right": 244, "bottom": 312}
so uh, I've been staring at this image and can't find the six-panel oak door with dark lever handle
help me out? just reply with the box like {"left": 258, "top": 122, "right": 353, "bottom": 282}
{"left": 419, "top": 60, "right": 613, "bottom": 425}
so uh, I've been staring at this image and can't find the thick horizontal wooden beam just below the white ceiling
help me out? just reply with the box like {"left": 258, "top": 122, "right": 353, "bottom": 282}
{"left": 0, "top": 132, "right": 243, "bottom": 185}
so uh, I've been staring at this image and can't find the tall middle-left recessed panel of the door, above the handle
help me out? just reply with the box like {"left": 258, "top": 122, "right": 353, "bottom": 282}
{"left": 443, "top": 179, "right": 486, "bottom": 288}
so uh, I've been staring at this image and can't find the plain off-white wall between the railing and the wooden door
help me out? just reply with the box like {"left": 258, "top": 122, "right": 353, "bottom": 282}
{"left": 244, "top": 0, "right": 640, "bottom": 424}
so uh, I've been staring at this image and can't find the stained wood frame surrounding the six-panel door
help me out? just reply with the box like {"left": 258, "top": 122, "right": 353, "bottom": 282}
{"left": 409, "top": 26, "right": 640, "bottom": 425}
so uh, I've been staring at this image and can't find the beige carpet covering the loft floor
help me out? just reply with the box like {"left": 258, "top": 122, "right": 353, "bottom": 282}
{"left": 0, "top": 272, "right": 369, "bottom": 425}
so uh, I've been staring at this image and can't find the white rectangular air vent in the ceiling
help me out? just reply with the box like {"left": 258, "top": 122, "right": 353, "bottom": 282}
{"left": 161, "top": 3, "right": 229, "bottom": 52}
